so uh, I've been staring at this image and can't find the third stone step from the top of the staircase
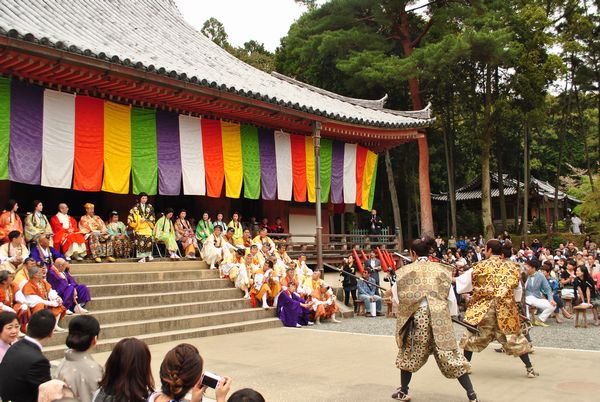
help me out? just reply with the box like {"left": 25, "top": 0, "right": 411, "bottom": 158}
{"left": 88, "top": 279, "right": 233, "bottom": 298}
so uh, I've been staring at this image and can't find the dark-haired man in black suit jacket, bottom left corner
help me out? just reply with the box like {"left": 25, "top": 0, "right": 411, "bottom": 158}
{"left": 0, "top": 309, "right": 56, "bottom": 402}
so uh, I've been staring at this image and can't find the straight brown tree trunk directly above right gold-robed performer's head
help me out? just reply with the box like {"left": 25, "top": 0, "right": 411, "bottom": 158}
{"left": 481, "top": 66, "right": 494, "bottom": 240}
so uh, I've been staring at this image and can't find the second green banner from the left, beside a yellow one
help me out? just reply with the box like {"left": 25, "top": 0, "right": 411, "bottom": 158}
{"left": 131, "top": 107, "right": 158, "bottom": 195}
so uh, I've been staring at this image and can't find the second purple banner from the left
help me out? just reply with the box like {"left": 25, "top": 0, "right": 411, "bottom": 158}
{"left": 156, "top": 110, "right": 181, "bottom": 195}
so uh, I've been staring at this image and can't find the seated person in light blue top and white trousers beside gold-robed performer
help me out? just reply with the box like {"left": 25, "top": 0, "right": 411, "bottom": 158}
{"left": 525, "top": 259, "right": 556, "bottom": 327}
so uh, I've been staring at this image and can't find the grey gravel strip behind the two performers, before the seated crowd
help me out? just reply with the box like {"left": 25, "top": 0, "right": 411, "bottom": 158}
{"left": 312, "top": 308, "right": 600, "bottom": 350}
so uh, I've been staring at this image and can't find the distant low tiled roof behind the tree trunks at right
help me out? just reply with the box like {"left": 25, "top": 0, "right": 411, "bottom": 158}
{"left": 431, "top": 173, "right": 581, "bottom": 204}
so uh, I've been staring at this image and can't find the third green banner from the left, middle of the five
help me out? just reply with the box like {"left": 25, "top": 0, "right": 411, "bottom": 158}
{"left": 240, "top": 124, "right": 262, "bottom": 200}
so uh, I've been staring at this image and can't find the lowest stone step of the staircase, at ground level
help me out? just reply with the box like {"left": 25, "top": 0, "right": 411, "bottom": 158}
{"left": 44, "top": 317, "right": 282, "bottom": 360}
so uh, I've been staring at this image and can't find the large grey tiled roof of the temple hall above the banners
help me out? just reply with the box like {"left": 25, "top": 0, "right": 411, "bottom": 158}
{"left": 0, "top": 0, "right": 432, "bottom": 128}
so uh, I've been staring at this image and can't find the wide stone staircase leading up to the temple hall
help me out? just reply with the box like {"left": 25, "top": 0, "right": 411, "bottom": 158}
{"left": 44, "top": 260, "right": 281, "bottom": 360}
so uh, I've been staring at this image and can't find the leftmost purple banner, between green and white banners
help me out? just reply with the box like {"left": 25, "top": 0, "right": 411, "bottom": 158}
{"left": 8, "top": 79, "right": 43, "bottom": 185}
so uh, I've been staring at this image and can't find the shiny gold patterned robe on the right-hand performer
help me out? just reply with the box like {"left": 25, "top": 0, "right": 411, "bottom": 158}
{"left": 464, "top": 255, "right": 521, "bottom": 335}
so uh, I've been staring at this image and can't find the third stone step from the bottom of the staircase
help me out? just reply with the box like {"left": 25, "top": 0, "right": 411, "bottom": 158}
{"left": 61, "top": 294, "right": 250, "bottom": 329}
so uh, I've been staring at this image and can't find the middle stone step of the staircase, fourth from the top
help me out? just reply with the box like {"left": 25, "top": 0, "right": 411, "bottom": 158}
{"left": 86, "top": 288, "right": 242, "bottom": 311}
